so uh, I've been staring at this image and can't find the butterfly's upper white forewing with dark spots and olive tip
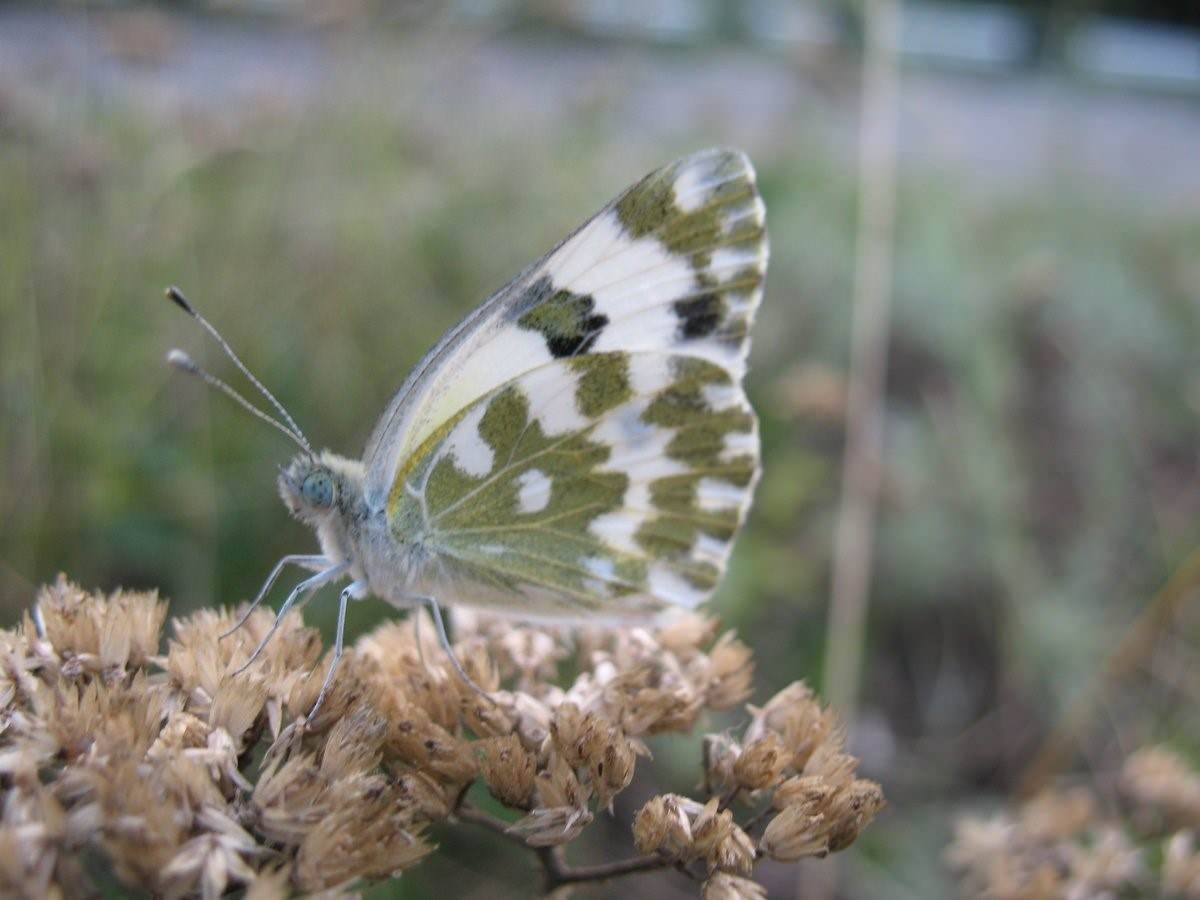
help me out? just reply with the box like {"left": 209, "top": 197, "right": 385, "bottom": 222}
{"left": 364, "top": 150, "right": 767, "bottom": 505}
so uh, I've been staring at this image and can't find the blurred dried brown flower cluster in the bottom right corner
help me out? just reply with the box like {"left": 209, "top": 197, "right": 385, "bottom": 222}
{"left": 946, "top": 748, "right": 1200, "bottom": 900}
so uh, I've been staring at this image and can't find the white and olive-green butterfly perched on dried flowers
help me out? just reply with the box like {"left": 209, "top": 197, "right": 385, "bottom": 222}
{"left": 167, "top": 149, "right": 768, "bottom": 718}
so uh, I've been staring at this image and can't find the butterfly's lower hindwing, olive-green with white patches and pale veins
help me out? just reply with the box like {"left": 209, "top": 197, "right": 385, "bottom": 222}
{"left": 388, "top": 352, "right": 758, "bottom": 620}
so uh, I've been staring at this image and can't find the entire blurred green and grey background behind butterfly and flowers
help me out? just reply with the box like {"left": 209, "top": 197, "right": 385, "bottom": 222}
{"left": 0, "top": 0, "right": 1200, "bottom": 898}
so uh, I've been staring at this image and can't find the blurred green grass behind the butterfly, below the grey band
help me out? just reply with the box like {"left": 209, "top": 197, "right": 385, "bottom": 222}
{"left": 0, "top": 33, "right": 1200, "bottom": 896}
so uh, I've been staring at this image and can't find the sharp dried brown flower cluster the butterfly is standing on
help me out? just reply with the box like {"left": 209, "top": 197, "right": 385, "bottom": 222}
{"left": 0, "top": 578, "right": 883, "bottom": 898}
